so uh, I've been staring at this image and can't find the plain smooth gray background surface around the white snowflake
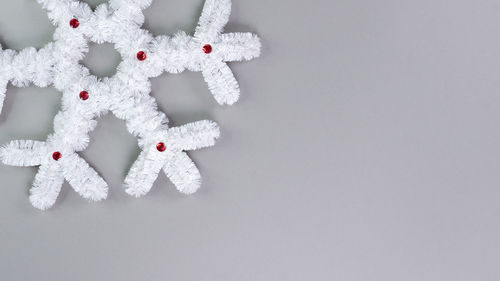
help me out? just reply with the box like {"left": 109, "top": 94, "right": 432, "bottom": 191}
{"left": 0, "top": 0, "right": 500, "bottom": 281}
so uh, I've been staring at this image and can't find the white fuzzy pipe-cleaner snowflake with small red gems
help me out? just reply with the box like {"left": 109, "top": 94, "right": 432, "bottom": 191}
{"left": 0, "top": 0, "right": 261, "bottom": 210}
